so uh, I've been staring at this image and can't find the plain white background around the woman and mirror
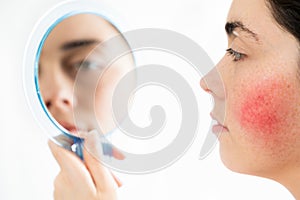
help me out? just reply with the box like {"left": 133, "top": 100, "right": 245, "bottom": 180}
{"left": 0, "top": 0, "right": 293, "bottom": 200}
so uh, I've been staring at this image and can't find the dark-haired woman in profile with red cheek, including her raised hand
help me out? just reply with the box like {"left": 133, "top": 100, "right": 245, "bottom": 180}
{"left": 50, "top": 0, "right": 300, "bottom": 200}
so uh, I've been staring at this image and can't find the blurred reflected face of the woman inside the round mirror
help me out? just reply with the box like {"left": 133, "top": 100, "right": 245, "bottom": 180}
{"left": 39, "top": 14, "right": 133, "bottom": 134}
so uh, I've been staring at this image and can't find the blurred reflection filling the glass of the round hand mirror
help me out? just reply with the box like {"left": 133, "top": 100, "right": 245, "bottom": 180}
{"left": 38, "top": 14, "right": 134, "bottom": 153}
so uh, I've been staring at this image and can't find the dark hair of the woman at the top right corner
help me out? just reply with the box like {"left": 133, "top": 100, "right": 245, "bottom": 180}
{"left": 266, "top": 0, "right": 300, "bottom": 44}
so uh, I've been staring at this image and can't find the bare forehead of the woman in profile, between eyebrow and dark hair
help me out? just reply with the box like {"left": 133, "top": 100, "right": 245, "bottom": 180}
{"left": 227, "top": 0, "right": 297, "bottom": 57}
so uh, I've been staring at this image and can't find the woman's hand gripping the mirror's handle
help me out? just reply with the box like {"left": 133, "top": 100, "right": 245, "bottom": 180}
{"left": 48, "top": 134, "right": 121, "bottom": 200}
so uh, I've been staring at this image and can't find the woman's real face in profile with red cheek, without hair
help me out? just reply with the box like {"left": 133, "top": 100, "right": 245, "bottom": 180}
{"left": 201, "top": 0, "right": 300, "bottom": 179}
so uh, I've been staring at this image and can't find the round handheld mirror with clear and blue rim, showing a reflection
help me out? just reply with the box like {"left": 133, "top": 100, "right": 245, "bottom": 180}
{"left": 24, "top": 1, "right": 134, "bottom": 158}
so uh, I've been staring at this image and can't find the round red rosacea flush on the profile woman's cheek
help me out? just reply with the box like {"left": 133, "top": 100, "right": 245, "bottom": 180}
{"left": 237, "top": 78, "right": 296, "bottom": 139}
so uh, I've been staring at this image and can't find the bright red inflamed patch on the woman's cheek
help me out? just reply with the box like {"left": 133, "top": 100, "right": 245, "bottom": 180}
{"left": 239, "top": 80, "right": 290, "bottom": 136}
